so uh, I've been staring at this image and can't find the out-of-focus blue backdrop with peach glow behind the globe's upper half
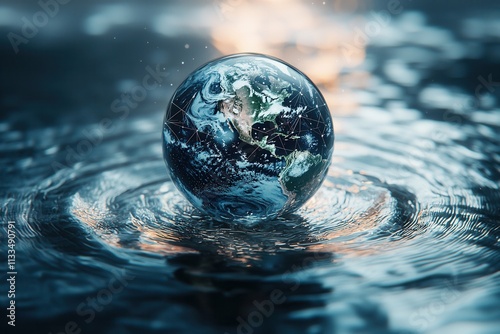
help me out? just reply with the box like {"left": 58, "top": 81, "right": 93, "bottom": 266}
{"left": 0, "top": 0, "right": 500, "bottom": 129}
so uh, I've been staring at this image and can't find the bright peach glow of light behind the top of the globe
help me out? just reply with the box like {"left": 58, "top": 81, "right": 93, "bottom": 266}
{"left": 211, "top": 0, "right": 368, "bottom": 115}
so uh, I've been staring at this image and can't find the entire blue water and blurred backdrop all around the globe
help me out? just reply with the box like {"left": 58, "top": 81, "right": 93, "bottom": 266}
{"left": 0, "top": 0, "right": 500, "bottom": 334}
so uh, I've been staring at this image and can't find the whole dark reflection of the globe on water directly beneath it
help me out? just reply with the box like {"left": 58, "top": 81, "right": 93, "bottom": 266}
{"left": 167, "top": 214, "right": 335, "bottom": 333}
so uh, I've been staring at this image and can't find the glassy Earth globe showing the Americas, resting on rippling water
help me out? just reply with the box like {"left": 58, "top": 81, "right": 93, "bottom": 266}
{"left": 163, "top": 54, "right": 334, "bottom": 223}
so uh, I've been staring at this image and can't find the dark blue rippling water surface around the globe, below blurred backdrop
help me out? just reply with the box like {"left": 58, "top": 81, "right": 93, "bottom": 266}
{"left": 0, "top": 0, "right": 500, "bottom": 333}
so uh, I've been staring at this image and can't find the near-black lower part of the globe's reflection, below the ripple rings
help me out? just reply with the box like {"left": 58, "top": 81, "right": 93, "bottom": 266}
{"left": 168, "top": 251, "right": 333, "bottom": 333}
